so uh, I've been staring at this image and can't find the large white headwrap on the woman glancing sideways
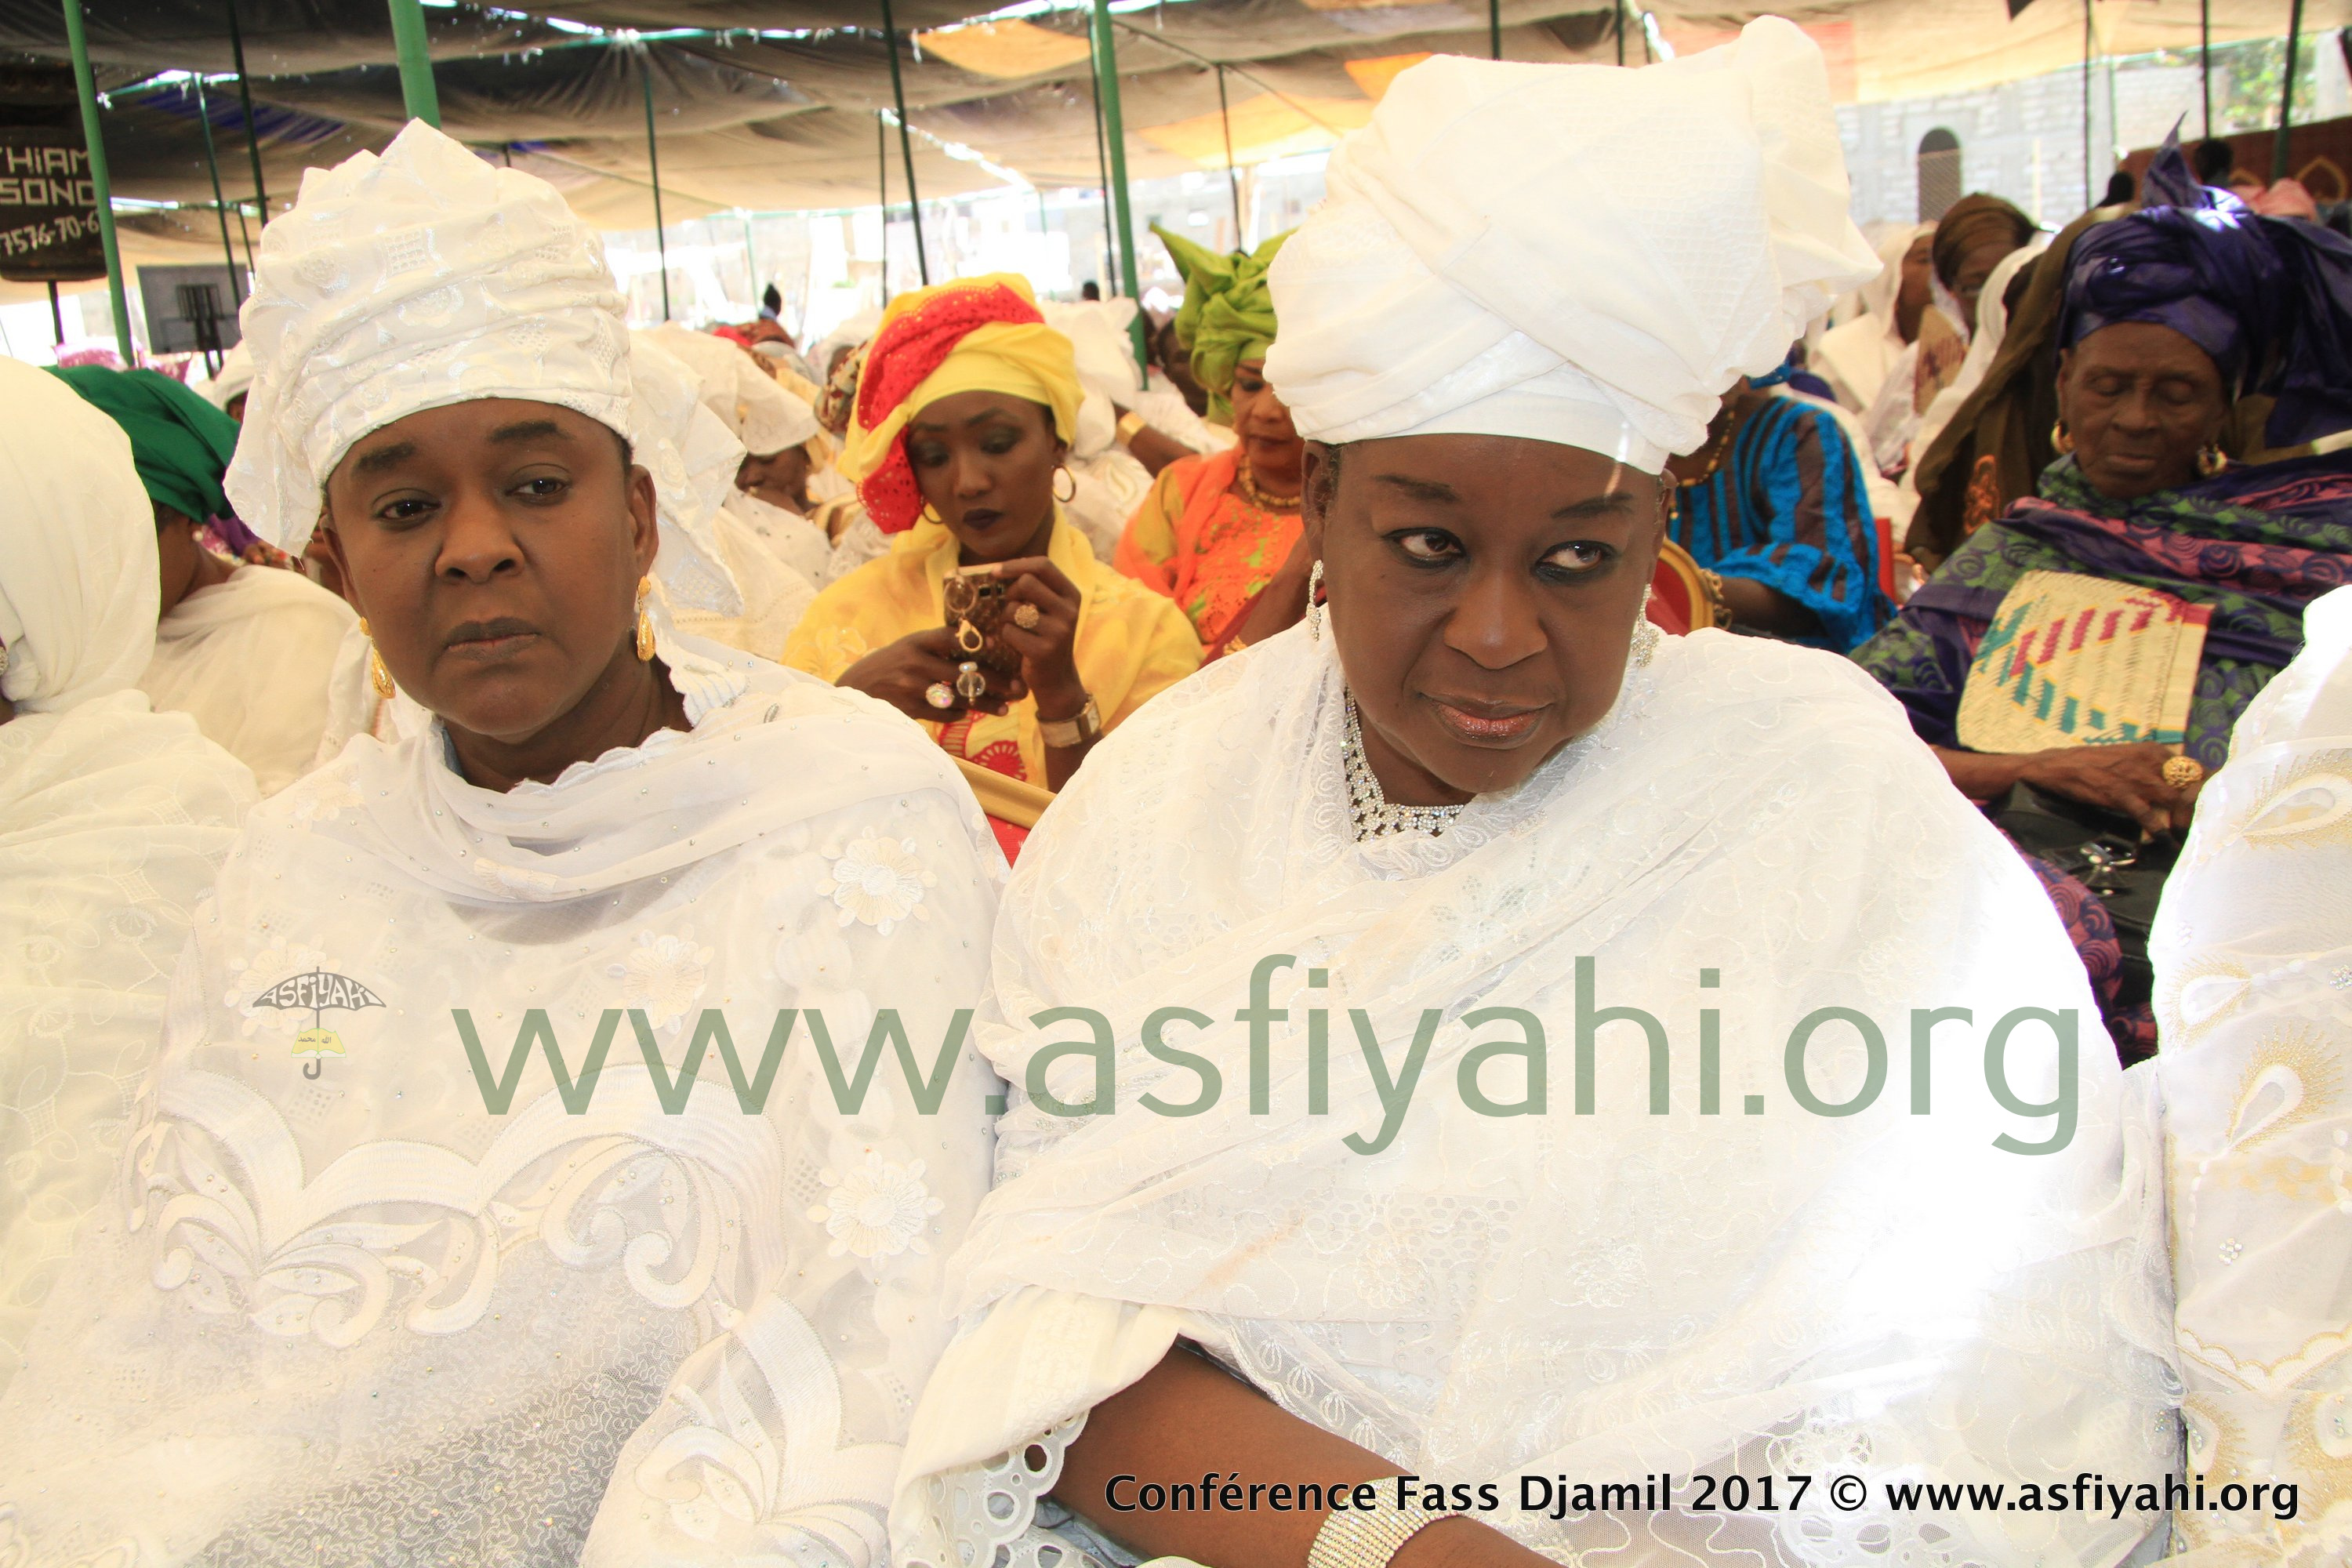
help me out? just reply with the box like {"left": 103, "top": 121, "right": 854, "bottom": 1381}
{"left": 1265, "top": 16, "right": 1879, "bottom": 473}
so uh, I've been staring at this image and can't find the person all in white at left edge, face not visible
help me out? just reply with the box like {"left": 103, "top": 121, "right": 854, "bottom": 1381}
{"left": 0, "top": 360, "right": 254, "bottom": 1387}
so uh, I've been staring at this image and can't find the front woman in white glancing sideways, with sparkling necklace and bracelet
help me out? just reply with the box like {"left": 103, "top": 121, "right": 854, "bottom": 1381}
{"left": 891, "top": 19, "right": 2176, "bottom": 1568}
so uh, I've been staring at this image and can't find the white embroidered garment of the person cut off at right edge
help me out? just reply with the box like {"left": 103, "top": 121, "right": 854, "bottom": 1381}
{"left": 2150, "top": 588, "right": 2352, "bottom": 1568}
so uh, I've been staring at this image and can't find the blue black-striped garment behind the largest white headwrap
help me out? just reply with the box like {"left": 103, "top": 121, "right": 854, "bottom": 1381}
{"left": 1672, "top": 397, "right": 1896, "bottom": 654}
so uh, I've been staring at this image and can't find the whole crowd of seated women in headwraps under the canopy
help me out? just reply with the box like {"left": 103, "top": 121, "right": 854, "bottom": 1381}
{"left": 0, "top": 19, "right": 2352, "bottom": 1568}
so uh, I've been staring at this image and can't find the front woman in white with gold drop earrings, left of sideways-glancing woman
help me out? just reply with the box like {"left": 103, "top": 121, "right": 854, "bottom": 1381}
{"left": 0, "top": 125, "right": 1000, "bottom": 1568}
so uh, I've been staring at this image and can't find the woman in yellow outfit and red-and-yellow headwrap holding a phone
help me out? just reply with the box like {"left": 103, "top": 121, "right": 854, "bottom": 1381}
{"left": 783, "top": 273, "right": 1200, "bottom": 789}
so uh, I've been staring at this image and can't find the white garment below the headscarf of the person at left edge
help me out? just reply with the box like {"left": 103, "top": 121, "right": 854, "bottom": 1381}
{"left": 0, "top": 691, "right": 254, "bottom": 1392}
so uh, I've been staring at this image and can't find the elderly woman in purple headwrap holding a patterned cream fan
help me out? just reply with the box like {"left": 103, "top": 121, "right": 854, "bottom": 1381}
{"left": 1856, "top": 151, "right": 2352, "bottom": 1053}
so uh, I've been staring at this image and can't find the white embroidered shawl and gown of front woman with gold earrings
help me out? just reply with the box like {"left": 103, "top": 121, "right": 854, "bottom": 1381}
{"left": 0, "top": 640, "right": 1002, "bottom": 1568}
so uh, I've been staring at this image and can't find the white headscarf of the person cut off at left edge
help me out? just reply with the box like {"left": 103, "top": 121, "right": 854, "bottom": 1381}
{"left": 0, "top": 360, "right": 155, "bottom": 713}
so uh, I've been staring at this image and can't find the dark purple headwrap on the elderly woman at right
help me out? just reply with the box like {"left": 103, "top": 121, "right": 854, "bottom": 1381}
{"left": 2058, "top": 139, "right": 2352, "bottom": 447}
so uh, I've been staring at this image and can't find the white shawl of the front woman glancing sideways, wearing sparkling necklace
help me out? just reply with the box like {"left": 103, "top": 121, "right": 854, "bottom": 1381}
{"left": 891, "top": 630, "right": 2178, "bottom": 1566}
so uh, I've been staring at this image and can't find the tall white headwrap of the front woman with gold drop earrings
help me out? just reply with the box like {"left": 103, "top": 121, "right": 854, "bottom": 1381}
{"left": 226, "top": 120, "right": 741, "bottom": 614}
